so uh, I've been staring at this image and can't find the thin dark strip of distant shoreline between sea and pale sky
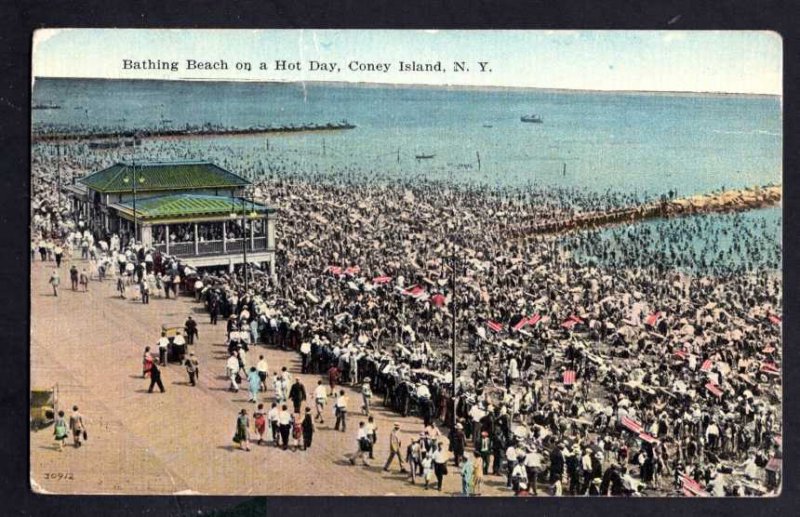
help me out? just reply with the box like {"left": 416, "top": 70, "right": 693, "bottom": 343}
{"left": 34, "top": 77, "right": 783, "bottom": 99}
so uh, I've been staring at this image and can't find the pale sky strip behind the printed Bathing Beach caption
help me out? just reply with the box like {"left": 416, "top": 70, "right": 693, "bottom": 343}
{"left": 33, "top": 29, "right": 783, "bottom": 95}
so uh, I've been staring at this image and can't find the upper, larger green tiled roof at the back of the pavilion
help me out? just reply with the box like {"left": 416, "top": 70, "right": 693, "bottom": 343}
{"left": 80, "top": 161, "right": 250, "bottom": 194}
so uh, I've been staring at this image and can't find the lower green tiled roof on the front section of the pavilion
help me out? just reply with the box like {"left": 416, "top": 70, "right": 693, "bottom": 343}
{"left": 114, "top": 194, "right": 274, "bottom": 220}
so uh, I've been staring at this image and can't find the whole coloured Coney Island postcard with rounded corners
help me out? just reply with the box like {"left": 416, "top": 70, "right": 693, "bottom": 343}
{"left": 30, "top": 29, "right": 783, "bottom": 497}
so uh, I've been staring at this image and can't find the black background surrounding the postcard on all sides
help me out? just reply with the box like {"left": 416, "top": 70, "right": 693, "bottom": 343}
{"left": 0, "top": 0, "right": 800, "bottom": 517}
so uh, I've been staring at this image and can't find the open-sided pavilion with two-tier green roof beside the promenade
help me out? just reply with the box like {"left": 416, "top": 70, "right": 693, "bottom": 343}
{"left": 67, "top": 161, "right": 275, "bottom": 275}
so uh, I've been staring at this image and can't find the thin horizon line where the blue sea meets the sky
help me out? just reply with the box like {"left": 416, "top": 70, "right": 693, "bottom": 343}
{"left": 32, "top": 76, "right": 783, "bottom": 98}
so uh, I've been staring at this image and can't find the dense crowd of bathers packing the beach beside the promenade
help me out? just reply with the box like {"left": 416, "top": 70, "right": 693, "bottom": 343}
{"left": 32, "top": 134, "right": 782, "bottom": 496}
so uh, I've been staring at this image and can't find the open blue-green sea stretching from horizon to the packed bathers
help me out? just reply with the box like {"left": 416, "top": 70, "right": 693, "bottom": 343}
{"left": 32, "top": 79, "right": 782, "bottom": 195}
